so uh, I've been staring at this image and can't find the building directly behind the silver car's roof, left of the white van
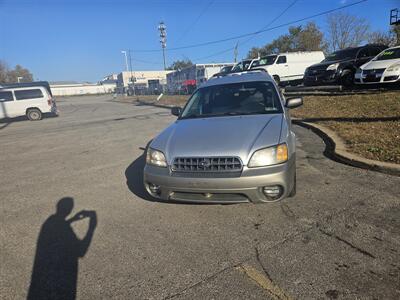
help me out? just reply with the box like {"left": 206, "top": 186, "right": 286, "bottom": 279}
{"left": 167, "top": 63, "right": 233, "bottom": 94}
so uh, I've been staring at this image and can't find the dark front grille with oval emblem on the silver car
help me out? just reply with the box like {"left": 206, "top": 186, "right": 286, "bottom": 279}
{"left": 171, "top": 156, "right": 242, "bottom": 173}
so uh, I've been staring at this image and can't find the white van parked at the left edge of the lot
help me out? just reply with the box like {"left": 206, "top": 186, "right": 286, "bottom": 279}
{"left": 0, "top": 86, "right": 58, "bottom": 121}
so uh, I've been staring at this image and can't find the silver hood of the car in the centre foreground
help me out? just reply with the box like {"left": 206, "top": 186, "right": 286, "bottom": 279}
{"left": 150, "top": 114, "right": 283, "bottom": 165}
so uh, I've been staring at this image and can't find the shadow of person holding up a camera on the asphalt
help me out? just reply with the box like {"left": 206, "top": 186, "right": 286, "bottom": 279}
{"left": 27, "top": 197, "right": 97, "bottom": 300}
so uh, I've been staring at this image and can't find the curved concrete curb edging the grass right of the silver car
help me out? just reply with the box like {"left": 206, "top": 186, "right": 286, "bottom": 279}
{"left": 292, "top": 119, "right": 400, "bottom": 177}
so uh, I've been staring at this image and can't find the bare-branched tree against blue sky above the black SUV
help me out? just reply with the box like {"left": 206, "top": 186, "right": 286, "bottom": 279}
{"left": 327, "top": 12, "right": 369, "bottom": 51}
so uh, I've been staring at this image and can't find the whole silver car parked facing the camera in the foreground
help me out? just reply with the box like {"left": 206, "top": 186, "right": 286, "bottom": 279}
{"left": 144, "top": 70, "right": 302, "bottom": 203}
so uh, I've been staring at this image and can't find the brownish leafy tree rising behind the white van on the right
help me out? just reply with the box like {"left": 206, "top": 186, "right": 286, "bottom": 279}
{"left": 247, "top": 22, "right": 327, "bottom": 58}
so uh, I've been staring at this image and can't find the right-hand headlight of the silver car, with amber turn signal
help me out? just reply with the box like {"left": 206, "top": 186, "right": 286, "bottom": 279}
{"left": 248, "top": 144, "right": 288, "bottom": 168}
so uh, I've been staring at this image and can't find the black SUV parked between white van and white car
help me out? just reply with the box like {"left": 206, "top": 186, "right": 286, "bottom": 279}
{"left": 303, "top": 44, "right": 387, "bottom": 86}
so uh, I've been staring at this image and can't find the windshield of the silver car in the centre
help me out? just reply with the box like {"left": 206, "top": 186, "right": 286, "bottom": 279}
{"left": 180, "top": 82, "right": 282, "bottom": 119}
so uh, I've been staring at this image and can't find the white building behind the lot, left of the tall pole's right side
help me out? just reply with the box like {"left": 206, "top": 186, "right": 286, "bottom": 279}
{"left": 117, "top": 71, "right": 172, "bottom": 92}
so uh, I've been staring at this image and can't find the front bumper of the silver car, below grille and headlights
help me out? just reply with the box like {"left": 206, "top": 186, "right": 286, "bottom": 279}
{"left": 143, "top": 156, "right": 296, "bottom": 203}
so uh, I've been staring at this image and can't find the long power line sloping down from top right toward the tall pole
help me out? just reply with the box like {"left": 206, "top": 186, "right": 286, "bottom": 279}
{"left": 135, "top": 0, "right": 368, "bottom": 52}
